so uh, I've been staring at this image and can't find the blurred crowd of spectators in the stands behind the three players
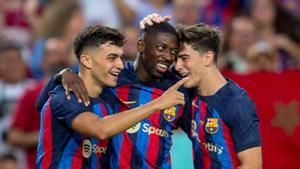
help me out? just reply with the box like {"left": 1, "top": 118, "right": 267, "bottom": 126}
{"left": 0, "top": 0, "right": 300, "bottom": 169}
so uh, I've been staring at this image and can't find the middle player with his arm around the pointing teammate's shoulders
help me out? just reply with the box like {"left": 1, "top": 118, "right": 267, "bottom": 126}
{"left": 38, "top": 22, "right": 183, "bottom": 169}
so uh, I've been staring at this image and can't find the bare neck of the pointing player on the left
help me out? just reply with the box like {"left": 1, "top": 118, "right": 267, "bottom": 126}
{"left": 79, "top": 71, "right": 103, "bottom": 97}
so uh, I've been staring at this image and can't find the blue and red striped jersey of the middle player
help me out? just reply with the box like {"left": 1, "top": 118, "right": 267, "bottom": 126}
{"left": 110, "top": 63, "right": 183, "bottom": 169}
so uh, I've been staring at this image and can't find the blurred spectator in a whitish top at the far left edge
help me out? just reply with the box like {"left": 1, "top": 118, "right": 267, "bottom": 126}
{"left": 0, "top": 43, "right": 32, "bottom": 169}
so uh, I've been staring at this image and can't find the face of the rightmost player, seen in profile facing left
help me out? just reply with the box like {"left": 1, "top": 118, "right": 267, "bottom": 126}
{"left": 175, "top": 43, "right": 205, "bottom": 88}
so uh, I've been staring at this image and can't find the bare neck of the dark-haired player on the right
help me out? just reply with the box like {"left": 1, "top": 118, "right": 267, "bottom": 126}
{"left": 197, "top": 66, "right": 227, "bottom": 96}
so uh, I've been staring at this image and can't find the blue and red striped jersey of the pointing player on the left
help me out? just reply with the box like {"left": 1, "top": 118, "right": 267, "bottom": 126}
{"left": 36, "top": 85, "right": 114, "bottom": 169}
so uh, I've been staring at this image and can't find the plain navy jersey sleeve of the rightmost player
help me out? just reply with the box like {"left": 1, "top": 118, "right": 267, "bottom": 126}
{"left": 225, "top": 99, "right": 261, "bottom": 153}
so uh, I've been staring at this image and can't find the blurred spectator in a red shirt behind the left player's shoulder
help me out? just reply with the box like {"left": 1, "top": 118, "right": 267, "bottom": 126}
{"left": 7, "top": 37, "right": 73, "bottom": 169}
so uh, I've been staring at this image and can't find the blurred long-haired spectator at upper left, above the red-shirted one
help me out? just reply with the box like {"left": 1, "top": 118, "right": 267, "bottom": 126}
{"left": 31, "top": 0, "right": 85, "bottom": 78}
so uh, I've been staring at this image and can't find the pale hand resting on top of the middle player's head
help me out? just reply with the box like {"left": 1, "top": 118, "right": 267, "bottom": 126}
{"left": 140, "top": 13, "right": 172, "bottom": 29}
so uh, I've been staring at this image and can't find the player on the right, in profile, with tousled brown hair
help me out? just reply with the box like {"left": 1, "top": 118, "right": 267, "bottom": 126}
{"left": 175, "top": 24, "right": 262, "bottom": 169}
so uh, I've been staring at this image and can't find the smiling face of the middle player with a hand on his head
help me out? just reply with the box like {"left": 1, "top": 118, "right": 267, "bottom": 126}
{"left": 143, "top": 32, "right": 179, "bottom": 78}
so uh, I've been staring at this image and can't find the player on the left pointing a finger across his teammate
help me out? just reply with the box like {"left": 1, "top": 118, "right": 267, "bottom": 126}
{"left": 36, "top": 26, "right": 184, "bottom": 169}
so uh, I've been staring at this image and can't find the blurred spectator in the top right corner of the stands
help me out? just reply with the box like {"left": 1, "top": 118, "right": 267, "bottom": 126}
{"left": 250, "top": 0, "right": 300, "bottom": 70}
